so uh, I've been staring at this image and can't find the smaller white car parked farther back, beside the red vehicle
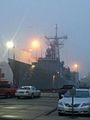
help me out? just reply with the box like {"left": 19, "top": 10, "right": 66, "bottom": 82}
{"left": 15, "top": 86, "right": 41, "bottom": 98}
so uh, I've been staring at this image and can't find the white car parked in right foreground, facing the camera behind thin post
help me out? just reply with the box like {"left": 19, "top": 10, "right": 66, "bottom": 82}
{"left": 57, "top": 89, "right": 90, "bottom": 115}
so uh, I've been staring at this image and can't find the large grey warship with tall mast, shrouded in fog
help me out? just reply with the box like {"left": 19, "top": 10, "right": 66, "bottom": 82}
{"left": 8, "top": 25, "right": 79, "bottom": 90}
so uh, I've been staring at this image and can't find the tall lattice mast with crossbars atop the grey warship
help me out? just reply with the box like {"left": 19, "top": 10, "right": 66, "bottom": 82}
{"left": 45, "top": 24, "right": 67, "bottom": 61}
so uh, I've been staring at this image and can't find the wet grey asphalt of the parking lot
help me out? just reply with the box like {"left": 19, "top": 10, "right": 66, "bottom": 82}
{"left": 0, "top": 93, "right": 90, "bottom": 120}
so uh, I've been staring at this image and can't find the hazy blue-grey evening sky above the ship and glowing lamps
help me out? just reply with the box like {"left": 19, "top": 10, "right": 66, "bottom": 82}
{"left": 0, "top": 0, "right": 90, "bottom": 76}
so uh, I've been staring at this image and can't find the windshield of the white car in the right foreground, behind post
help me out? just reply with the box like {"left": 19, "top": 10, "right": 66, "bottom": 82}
{"left": 64, "top": 91, "right": 90, "bottom": 98}
